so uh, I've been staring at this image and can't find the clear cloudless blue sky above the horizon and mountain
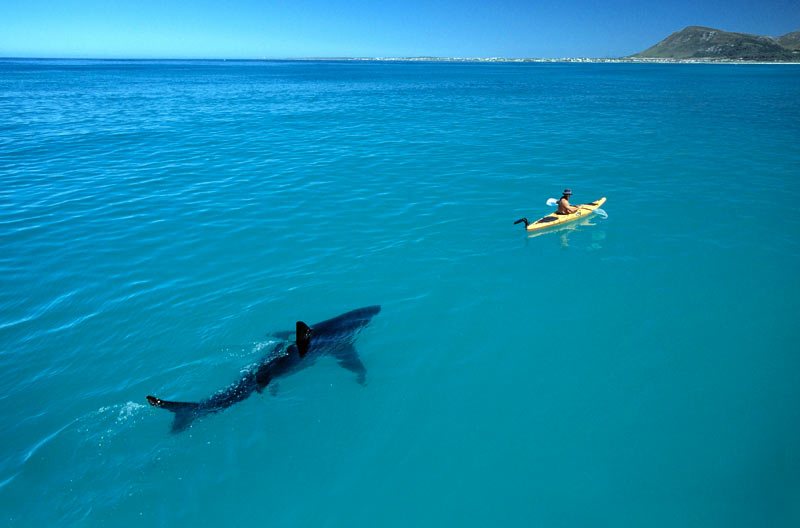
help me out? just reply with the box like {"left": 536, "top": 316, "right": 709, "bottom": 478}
{"left": 0, "top": 0, "right": 800, "bottom": 59}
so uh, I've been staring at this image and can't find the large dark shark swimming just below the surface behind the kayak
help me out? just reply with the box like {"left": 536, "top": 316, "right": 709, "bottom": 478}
{"left": 147, "top": 305, "right": 381, "bottom": 433}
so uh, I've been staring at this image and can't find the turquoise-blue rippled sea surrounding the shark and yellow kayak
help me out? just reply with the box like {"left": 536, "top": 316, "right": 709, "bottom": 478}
{"left": 0, "top": 60, "right": 800, "bottom": 528}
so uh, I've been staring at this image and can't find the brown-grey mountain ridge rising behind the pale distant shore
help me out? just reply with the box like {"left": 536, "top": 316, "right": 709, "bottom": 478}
{"left": 633, "top": 26, "right": 800, "bottom": 61}
